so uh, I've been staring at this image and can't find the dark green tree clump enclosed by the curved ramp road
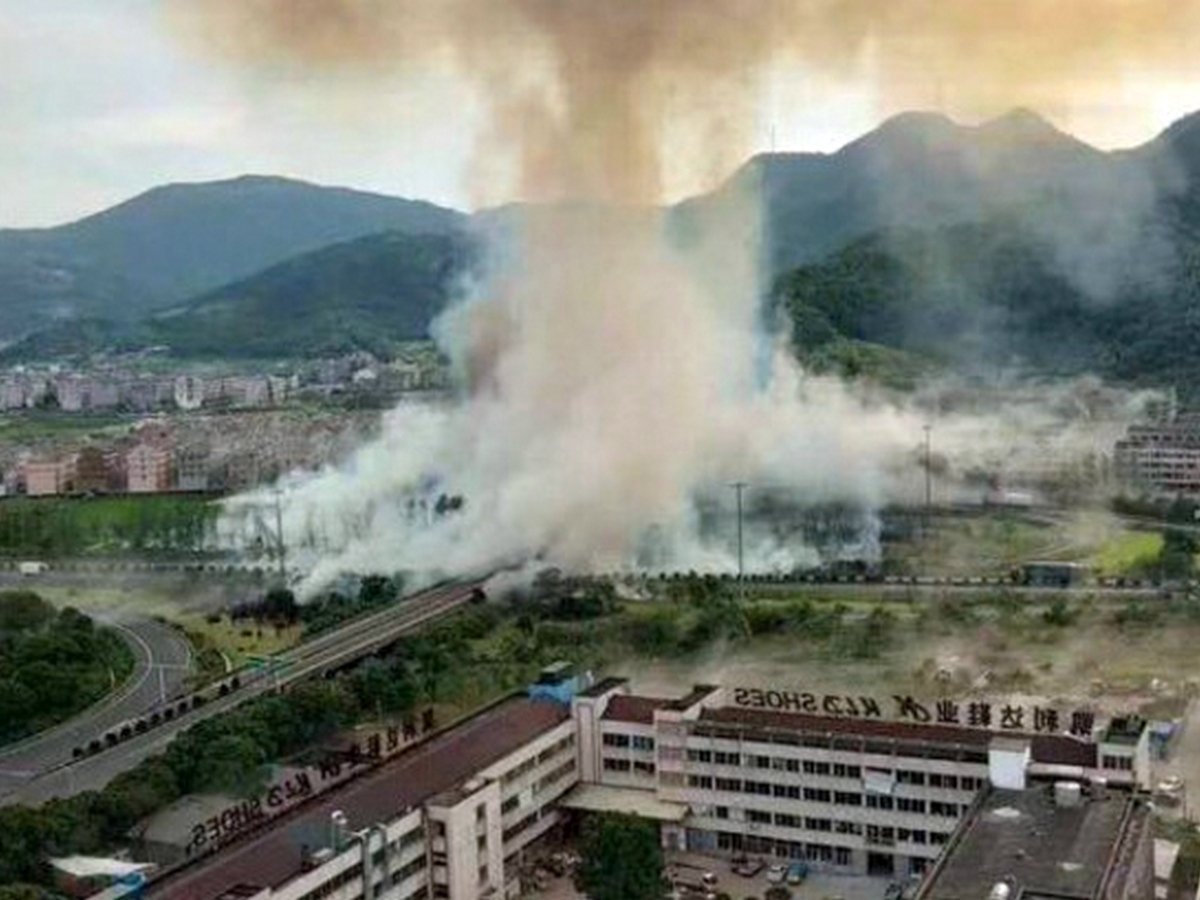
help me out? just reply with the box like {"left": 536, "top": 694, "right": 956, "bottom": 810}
{"left": 0, "top": 590, "right": 133, "bottom": 745}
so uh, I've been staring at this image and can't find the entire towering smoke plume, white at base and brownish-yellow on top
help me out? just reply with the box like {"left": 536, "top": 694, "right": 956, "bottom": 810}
{"left": 180, "top": 0, "right": 1180, "bottom": 592}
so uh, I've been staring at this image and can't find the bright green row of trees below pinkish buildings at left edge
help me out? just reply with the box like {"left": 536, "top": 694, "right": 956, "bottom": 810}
{"left": 0, "top": 496, "right": 220, "bottom": 557}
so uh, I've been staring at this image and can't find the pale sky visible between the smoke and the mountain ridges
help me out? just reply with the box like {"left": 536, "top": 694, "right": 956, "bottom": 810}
{"left": 0, "top": 0, "right": 1200, "bottom": 227}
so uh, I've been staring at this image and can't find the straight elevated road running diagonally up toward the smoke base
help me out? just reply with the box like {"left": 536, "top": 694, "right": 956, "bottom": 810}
{"left": 0, "top": 583, "right": 479, "bottom": 805}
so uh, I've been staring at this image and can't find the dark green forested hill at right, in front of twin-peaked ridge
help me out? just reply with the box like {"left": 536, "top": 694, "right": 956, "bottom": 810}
{"left": 774, "top": 218, "right": 1200, "bottom": 400}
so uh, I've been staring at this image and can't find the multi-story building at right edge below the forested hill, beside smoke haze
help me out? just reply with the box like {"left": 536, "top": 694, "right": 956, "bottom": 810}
{"left": 1114, "top": 413, "right": 1200, "bottom": 497}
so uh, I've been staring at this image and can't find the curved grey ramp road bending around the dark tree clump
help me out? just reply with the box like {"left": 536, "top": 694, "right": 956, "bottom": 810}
{"left": 0, "top": 614, "right": 192, "bottom": 797}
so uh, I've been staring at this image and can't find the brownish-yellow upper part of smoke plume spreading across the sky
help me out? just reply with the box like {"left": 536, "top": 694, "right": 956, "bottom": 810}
{"left": 168, "top": 0, "right": 1200, "bottom": 203}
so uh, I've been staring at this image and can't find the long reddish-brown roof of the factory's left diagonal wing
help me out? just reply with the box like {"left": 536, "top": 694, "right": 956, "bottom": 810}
{"left": 145, "top": 696, "right": 570, "bottom": 900}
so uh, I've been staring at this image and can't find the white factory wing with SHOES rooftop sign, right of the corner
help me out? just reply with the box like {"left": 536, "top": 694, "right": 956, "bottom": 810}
{"left": 568, "top": 680, "right": 1151, "bottom": 876}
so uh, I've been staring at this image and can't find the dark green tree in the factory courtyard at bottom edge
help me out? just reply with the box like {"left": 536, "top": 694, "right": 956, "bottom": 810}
{"left": 575, "top": 814, "right": 666, "bottom": 900}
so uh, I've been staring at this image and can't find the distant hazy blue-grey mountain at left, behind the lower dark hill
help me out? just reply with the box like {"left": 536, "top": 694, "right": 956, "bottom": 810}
{"left": 0, "top": 176, "right": 466, "bottom": 341}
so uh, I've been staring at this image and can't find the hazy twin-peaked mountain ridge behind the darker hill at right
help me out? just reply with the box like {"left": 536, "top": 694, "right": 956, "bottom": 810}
{"left": 674, "top": 109, "right": 1180, "bottom": 272}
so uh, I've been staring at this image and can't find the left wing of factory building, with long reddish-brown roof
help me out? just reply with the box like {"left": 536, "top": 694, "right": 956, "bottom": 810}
{"left": 145, "top": 696, "right": 577, "bottom": 900}
